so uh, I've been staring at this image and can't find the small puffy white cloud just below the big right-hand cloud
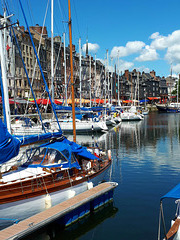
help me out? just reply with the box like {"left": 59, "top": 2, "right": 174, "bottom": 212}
{"left": 135, "top": 45, "right": 158, "bottom": 62}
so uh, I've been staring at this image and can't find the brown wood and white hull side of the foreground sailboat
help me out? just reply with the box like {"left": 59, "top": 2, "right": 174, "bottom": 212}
{"left": 0, "top": 161, "right": 110, "bottom": 227}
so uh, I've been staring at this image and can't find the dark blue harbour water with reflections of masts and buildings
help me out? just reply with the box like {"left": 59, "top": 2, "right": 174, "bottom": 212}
{"left": 25, "top": 113, "right": 180, "bottom": 240}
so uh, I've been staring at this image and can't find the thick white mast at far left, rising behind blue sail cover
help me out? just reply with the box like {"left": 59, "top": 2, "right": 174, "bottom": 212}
{"left": 0, "top": 17, "right": 11, "bottom": 133}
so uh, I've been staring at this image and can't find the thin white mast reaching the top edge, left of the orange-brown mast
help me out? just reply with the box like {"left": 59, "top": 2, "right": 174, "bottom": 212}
{"left": 51, "top": 0, "right": 54, "bottom": 102}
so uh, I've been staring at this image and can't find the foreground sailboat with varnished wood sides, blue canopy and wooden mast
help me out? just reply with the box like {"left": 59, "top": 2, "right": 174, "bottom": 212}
{"left": 0, "top": 0, "right": 111, "bottom": 228}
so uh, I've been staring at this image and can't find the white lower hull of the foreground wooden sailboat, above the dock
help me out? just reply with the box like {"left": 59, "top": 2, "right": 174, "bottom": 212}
{"left": 0, "top": 169, "right": 108, "bottom": 228}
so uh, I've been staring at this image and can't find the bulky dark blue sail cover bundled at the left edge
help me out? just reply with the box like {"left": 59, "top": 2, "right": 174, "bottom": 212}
{"left": 0, "top": 119, "right": 20, "bottom": 164}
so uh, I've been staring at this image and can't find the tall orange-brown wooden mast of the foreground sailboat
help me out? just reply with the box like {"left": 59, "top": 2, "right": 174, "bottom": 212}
{"left": 68, "top": 0, "right": 76, "bottom": 142}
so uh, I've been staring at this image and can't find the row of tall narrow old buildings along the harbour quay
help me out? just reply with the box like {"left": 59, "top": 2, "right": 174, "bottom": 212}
{"left": 1, "top": 20, "right": 177, "bottom": 101}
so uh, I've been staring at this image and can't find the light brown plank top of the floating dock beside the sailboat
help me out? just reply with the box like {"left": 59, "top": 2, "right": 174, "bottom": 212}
{"left": 0, "top": 182, "right": 117, "bottom": 240}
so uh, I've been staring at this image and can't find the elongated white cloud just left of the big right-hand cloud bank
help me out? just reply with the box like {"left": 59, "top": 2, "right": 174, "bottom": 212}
{"left": 111, "top": 41, "right": 146, "bottom": 58}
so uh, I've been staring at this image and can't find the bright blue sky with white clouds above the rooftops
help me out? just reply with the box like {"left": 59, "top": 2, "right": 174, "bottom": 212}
{"left": 4, "top": 0, "right": 180, "bottom": 76}
